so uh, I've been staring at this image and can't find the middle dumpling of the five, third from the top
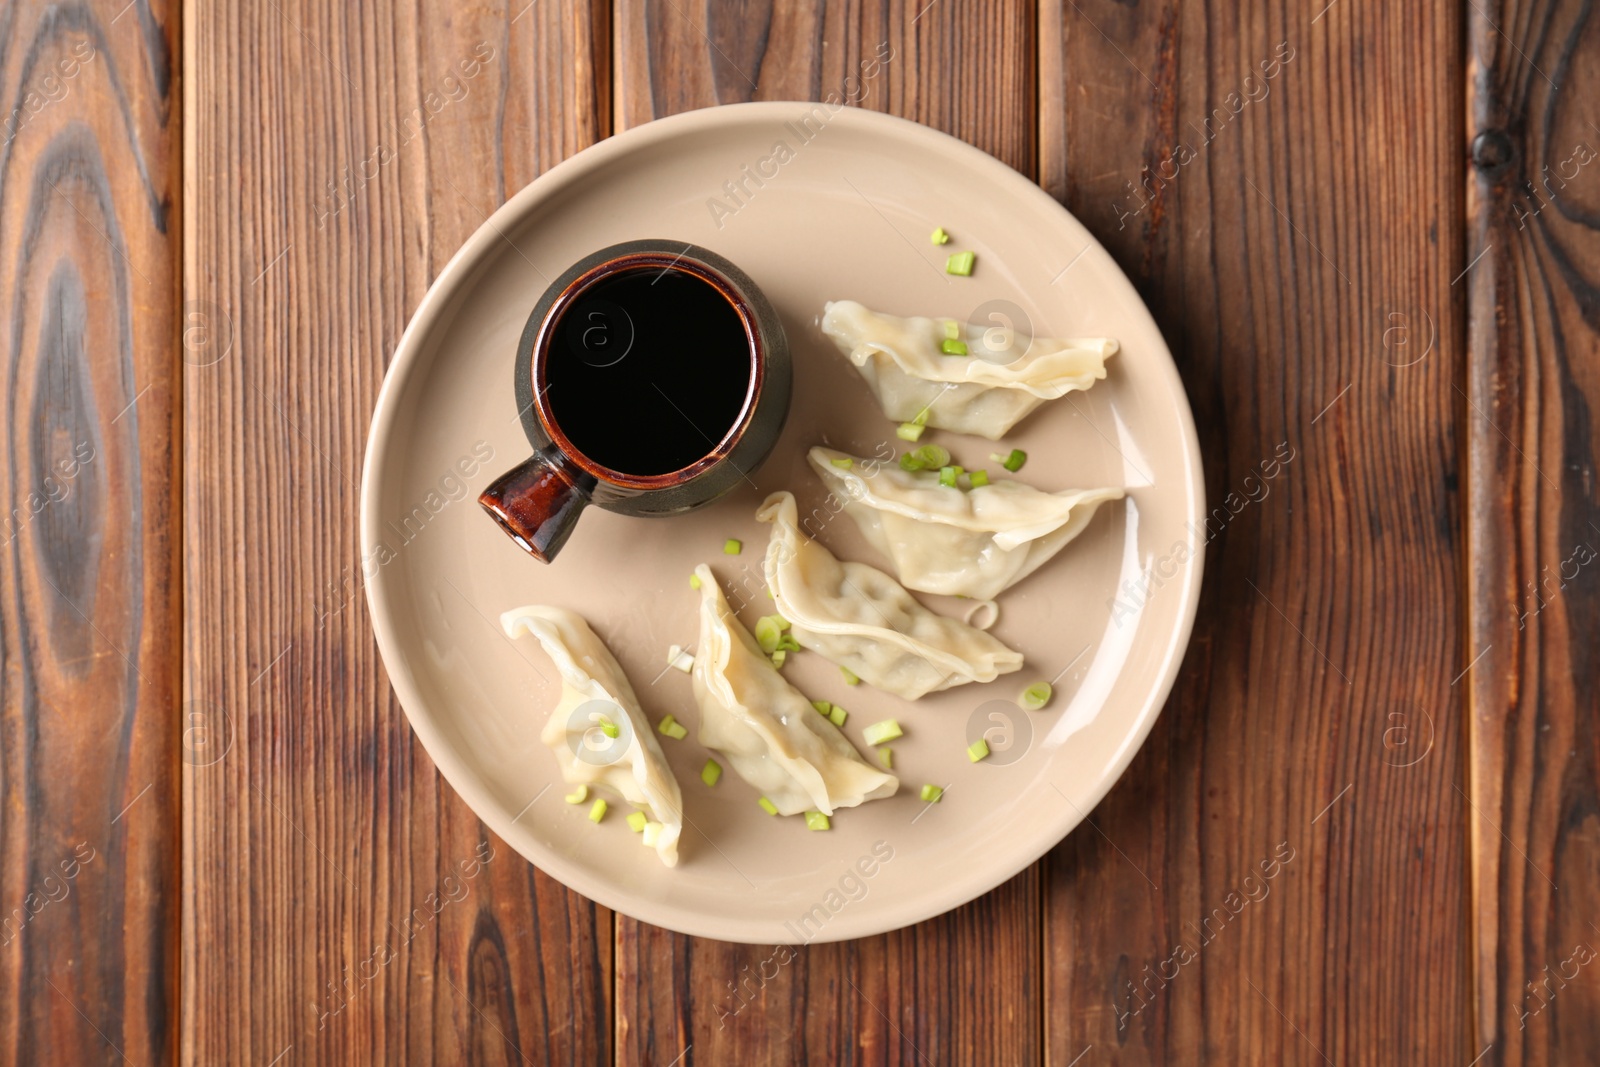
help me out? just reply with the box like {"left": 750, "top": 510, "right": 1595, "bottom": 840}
{"left": 755, "top": 493, "right": 1022, "bottom": 701}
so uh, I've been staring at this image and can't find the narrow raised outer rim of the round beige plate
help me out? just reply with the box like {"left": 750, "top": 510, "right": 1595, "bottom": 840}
{"left": 358, "top": 101, "right": 1206, "bottom": 945}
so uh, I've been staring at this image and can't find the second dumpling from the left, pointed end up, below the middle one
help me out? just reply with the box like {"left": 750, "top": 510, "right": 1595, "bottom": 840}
{"left": 693, "top": 563, "right": 899, "bottom": 816}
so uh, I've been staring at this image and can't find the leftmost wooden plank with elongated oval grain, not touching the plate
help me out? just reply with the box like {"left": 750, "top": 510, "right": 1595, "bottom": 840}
{"left": 0, "top": 0, "right": 179, "bottom": 1064}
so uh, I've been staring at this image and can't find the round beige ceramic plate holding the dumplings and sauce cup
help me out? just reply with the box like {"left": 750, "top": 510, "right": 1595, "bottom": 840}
{"left": 362, "top": 102, "right": 1203, "bottom": 944}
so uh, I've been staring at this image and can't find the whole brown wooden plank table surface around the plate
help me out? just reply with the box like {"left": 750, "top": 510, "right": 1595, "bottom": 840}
{"left": 0, "top": 0, "right": 1600, "bottom": 1067}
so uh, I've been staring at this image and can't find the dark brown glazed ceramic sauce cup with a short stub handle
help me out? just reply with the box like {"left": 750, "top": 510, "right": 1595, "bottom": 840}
{"left": 478, "top": 240, "right": 792, "bottom": 563}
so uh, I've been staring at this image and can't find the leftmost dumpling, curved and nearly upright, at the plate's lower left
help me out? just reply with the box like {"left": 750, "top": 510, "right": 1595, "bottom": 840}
{"left": 501, "top": 605, "right": 683, "bottom": 867}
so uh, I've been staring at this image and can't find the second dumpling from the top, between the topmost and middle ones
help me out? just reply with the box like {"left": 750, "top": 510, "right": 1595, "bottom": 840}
{"left": 806, "top": 448, "right": 1123, "bottom": 600}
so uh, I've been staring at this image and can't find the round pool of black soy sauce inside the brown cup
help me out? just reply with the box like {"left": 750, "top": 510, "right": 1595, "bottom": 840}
{"left": 546, "top": 267, "right": 754, "bottom": 475}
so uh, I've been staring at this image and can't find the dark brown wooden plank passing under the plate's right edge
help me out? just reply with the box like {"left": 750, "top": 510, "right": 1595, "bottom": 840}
{"left": 1040, "top": 0, "right": 1475, "bottom": 1065}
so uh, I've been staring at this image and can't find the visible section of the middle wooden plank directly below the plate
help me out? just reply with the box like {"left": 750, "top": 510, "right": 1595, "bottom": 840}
{"left": 616, "top": 865, "right": 1042, "bottom": 1067}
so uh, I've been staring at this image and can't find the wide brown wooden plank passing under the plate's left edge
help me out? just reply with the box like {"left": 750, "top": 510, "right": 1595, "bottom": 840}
{"left": 182, "top": 0, "right": 611, "bottom": 1064}
